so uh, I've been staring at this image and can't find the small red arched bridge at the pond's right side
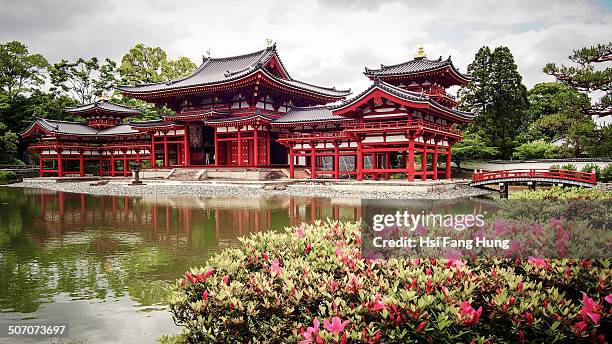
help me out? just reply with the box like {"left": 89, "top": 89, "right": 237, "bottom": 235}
{"left": 470, "top": 169, "right": 597, "bottom": 188}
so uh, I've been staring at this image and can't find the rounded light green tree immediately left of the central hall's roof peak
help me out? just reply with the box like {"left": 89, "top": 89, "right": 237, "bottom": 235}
{"left": 119, "top": 44, "right": 196, "bottom": 85}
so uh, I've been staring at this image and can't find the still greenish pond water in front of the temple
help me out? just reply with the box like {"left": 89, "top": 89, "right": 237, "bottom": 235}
{"left": 0, "top": 187, "right": 488, "bottom": 343}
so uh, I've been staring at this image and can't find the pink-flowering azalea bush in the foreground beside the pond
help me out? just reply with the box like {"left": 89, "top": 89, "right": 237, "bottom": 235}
{"left": 165, "top": 222, "right": 612, "bottom": 343}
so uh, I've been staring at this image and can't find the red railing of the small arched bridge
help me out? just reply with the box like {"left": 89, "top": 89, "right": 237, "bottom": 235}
{"left": 472, "top": 169, "right": 597, "bottom": 184}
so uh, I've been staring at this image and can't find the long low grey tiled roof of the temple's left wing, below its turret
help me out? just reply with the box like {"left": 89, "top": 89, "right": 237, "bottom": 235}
{"left": 24, "top": 118, "right": 138, "bottom": 136}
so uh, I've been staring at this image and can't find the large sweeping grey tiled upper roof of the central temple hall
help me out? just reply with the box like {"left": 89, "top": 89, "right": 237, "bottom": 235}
{"left": 118, "top": 45, "right": 350, "bottom": 97}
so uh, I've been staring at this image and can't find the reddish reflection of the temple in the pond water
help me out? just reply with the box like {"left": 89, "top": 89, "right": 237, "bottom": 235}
{"left": 28, "top": 189, "right": 361, "bottom": 240}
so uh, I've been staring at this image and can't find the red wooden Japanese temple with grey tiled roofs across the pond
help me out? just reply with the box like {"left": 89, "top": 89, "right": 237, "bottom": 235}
{"left": 22, "top": 45, "right": 474, "bottom": 180}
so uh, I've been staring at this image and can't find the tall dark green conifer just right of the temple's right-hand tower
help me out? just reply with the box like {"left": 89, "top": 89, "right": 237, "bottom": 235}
{"left": 460, "top": 46, "right": 529, "bottom": 158}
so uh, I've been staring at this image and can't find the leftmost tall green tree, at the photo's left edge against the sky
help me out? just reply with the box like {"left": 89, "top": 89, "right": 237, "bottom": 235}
{"left": 0, "top": 41, "right": 49, "bottom": 101}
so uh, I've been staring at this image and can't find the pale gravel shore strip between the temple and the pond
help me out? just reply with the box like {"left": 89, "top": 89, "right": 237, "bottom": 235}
{"left": 11, "top": 181, "right": 490, "bottom": 199}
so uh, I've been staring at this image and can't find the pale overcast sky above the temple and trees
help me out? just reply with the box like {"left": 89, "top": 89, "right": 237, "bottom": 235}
{"left": 0, "top": 0, "right": 612, "bottom": 92}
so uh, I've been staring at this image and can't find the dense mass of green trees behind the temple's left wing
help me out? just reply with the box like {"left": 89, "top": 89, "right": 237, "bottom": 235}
{"left": 0, "top": 41, "right": 196, "bottom": 164}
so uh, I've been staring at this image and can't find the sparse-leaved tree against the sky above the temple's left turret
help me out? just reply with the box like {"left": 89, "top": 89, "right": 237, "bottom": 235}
{"left": 49, "top": 57, "right": 118, "bottom": 104}
